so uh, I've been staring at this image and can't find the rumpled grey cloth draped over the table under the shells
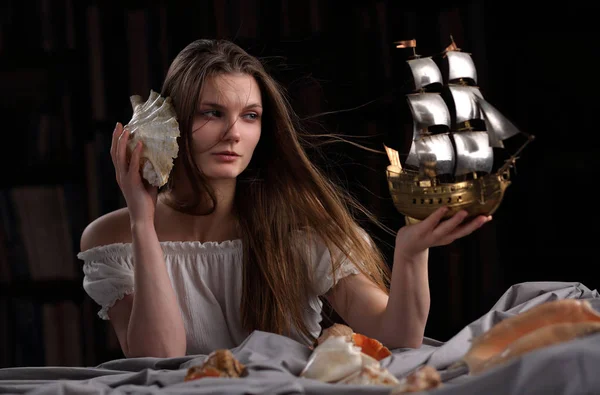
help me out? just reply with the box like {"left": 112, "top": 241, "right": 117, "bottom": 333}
{"left": 0, "top": 282, "right": 600, "bottom": 395}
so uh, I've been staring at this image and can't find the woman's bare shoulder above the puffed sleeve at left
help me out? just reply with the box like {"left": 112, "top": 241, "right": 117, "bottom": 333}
{"left": 80, "top": 208, "right": 131, "bottom": 251}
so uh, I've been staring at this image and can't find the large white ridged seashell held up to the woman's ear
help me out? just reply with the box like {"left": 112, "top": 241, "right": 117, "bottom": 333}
{"left": 125, "top": 90, "right": 180, "bottom": 187}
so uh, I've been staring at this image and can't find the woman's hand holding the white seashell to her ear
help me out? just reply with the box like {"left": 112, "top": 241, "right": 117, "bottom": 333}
{"left": 110, "top": 122, "right": 158, "bottom": 226}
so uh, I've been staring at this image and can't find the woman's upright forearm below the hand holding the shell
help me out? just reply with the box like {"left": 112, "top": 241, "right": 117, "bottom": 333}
{"left": 127, "top": 223, "right": 186, "bottom": 358}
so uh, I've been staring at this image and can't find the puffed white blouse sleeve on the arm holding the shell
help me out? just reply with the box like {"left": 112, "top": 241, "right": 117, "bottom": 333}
{"left": 77, "top": 244, "right": 134, "bottom": 320}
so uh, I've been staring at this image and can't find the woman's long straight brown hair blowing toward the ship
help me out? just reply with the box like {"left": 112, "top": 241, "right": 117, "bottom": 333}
{"left": 162, "top": 39, "right": 389, "bottom": 340}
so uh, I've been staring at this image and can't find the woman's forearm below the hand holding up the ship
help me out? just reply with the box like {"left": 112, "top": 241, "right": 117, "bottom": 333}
{"left": 382, "top": 250, "right": 430, "bottom": 348}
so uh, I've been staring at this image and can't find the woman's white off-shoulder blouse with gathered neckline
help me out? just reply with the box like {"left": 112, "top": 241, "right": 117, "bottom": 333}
{"left": 77, "top": 234, "right": 359, "bottom": 355}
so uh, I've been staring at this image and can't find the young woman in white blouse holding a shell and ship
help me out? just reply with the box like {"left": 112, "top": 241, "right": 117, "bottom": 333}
{"left": 78, "top": 40, "right": 490, "bottom": 357}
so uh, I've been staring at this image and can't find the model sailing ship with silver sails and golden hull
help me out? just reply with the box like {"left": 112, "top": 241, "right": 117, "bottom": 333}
{"left": 385, "top": 37, "right": 534, "bottom": 223}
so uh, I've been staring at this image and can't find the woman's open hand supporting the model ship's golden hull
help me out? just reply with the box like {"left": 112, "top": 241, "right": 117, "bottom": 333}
{"left": 396, "top": 207, "right": 492, "bottom": 260}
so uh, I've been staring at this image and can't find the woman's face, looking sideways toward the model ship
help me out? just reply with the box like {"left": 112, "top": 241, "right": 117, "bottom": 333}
{"left": 192, "top": 74, "right": 263, "bottom": 180}
